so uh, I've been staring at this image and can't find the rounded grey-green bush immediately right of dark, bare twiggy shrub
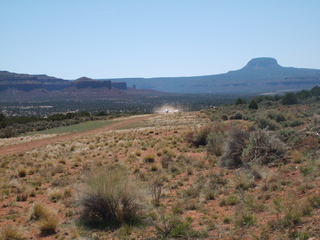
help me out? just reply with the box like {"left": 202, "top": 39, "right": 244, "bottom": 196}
{"left": 241, "top": 129, "right": 286, "bottom": 165}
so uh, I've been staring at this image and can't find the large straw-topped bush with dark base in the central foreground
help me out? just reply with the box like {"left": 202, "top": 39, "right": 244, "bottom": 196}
{"left": 80, "top": 169, "right": 142, "bottom": 227}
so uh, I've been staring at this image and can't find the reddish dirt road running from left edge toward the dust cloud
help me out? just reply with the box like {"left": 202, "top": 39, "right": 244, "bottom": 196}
{"left": 0, "top": 115, "right": 151, "bottom": 157}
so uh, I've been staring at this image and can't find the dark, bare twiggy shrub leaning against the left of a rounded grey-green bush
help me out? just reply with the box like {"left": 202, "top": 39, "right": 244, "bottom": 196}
{"left": 220, "top": 128, "right": 249, "bottom": 168}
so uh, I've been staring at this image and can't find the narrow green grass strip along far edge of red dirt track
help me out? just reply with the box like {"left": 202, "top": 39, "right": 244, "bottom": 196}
{"left": 27, "top": 121, "right": 119, "bottom": 136}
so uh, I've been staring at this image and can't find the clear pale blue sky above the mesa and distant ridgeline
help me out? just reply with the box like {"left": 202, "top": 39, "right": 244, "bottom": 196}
{"left": 0, "top": 0, "right": 320, "bottom": 79}
